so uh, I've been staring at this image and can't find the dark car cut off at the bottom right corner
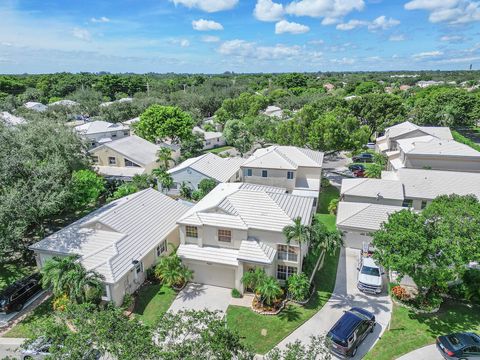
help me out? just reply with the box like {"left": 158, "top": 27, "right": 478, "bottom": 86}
{"left": 437, "top": 333, "right": 480, "bottom": 360}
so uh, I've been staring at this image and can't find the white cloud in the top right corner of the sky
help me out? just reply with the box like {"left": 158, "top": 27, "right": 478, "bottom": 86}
{"left": 405, "top": 0, "right": 480, "bottom": 24}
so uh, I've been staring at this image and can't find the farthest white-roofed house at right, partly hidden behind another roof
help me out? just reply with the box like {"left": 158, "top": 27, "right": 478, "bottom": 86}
{"left": 375, "top": 121, "right": 453, "bottom": 153}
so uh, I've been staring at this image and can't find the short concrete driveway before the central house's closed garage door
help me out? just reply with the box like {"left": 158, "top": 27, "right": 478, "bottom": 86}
{"left": 168, "top": 283, "right": 232, "bottom": 313}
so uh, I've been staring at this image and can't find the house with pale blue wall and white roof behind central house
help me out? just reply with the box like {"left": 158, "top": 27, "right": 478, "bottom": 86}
{"left": 168, "top": 153, "right": 245, "bottom": 195}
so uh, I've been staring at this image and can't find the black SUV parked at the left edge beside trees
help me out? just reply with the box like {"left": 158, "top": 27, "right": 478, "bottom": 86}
{"left": 0, "top": 273, "right": 42, "bottom": 314}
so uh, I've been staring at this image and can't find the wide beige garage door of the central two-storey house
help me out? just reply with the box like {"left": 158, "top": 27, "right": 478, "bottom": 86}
{"left": 185, "top": 262, "right": 235, "bottom": 289}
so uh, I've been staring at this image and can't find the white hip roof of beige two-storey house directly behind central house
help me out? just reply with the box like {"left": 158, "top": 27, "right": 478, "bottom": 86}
{"left": 242, "top": 145, "right": 323, "bottom": 170}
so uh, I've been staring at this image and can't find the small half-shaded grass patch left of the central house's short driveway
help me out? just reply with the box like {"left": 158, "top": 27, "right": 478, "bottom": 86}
{"left": 133, "top": 284, "right": 177, "bottom": 325}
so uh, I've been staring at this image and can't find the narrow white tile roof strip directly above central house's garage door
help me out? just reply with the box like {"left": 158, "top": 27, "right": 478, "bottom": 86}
{"left": 177, "top": 244, "right": 238, "bottom": 266}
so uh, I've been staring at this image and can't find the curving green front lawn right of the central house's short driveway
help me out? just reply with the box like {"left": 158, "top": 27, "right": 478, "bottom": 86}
{"left": 227, "top": 251, "right": 339, "bottom": 354}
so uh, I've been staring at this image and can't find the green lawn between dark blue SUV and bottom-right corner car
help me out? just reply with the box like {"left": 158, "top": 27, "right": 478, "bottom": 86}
{"left": 365, "top": 302, "right": 480, "bottom": 360}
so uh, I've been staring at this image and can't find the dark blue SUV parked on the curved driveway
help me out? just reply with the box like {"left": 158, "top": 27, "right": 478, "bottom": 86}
{"left": 327, "top": 307, "right": 376, "bottom": 358}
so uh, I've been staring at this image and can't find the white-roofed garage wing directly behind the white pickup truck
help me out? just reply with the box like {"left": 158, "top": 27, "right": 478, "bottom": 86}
{"left": 336, "top": 201, "right": 405, "bottom": 249}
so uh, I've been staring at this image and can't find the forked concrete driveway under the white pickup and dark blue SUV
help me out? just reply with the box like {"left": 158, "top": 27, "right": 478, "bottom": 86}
{"left": 278, "top": 248, "right": 392, "bottom": 359}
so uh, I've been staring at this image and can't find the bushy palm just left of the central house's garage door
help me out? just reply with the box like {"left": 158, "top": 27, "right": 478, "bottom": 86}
{"left": 155, "top": 252, "right": 193, "bottom": 288}
